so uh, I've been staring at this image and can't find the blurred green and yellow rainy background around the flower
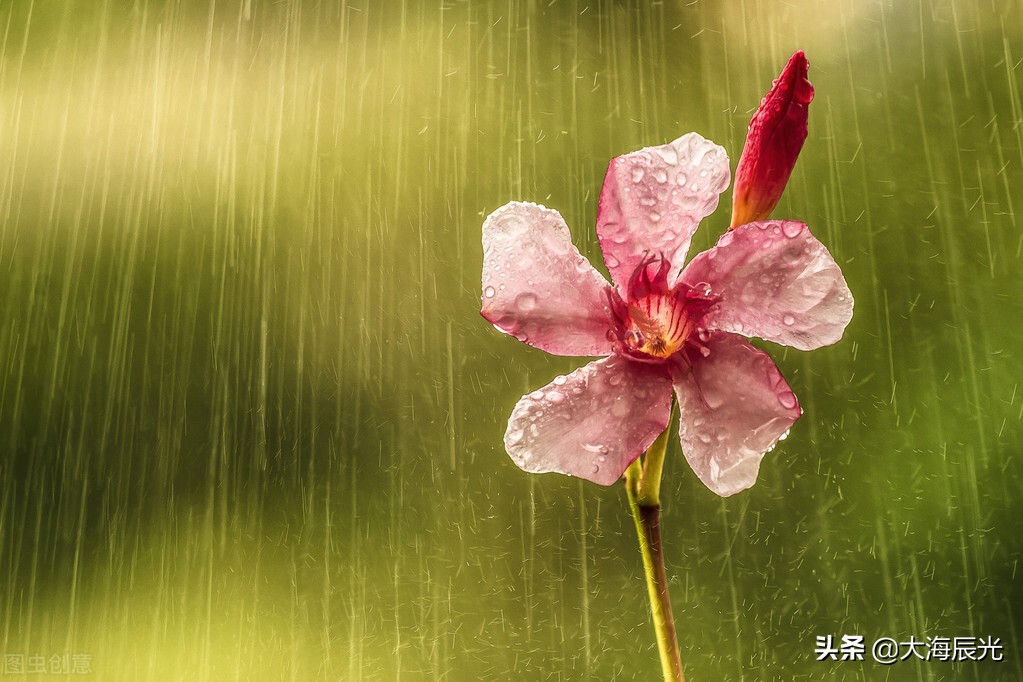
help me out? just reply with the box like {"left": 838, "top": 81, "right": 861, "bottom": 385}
{"left": 0, "top": 0, "right": 1023, "bottom": 682}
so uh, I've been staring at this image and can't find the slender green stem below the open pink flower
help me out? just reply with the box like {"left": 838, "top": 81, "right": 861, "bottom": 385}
{"left": 625, "top": 428, "right": 685, "bottom": 682}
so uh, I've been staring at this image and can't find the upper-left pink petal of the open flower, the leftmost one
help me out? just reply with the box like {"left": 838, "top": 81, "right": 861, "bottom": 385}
{"left": 480, "top": 201, "right": 611, "bottom": 356}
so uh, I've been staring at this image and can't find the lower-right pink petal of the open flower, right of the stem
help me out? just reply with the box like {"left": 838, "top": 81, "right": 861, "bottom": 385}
{"left": 672, "top": 331, "right": 802, "bottom": 497}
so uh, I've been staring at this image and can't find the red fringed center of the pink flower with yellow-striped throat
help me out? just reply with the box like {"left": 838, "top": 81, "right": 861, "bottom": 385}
{"left": 608, "top": 255, "right": 716, "bottom": 362}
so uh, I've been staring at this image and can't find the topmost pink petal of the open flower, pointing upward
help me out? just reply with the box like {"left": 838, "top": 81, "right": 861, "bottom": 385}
{"left": 596, "top": 133, "right": 728, "bottom": 298}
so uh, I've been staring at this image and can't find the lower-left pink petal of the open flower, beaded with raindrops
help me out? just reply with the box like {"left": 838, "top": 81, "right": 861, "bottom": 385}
{"left": 504, "top": 357, "right": 671, "bottom": 486}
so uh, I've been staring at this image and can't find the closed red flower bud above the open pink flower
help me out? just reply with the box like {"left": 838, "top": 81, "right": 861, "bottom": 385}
{"left": 731, "top": 50, "right": 813, "bottom": 227}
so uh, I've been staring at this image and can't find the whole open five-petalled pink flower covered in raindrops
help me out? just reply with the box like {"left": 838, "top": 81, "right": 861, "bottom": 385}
{"left": 481, "top": 133, "right": 852, "bottom": 496}
